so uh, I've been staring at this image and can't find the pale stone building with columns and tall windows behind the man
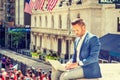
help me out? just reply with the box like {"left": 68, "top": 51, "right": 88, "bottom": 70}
{"left": 31, "top": 0, "right": 120, "bottom": 58}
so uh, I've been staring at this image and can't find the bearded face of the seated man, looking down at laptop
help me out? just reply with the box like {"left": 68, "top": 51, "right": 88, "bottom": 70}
{"left": 72, "top": 24, "right": 85, "bottom": 37}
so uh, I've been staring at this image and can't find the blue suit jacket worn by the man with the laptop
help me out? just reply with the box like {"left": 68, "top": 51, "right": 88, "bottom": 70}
{"left": 72, "top": 33, "right": 101, "bottom": 78}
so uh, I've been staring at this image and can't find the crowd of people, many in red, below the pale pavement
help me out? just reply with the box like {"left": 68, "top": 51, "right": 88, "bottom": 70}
{"left": 0, "top": 56, "right": 51, "bottom": 80}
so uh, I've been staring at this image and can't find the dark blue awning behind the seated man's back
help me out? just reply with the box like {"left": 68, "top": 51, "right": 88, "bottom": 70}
{"left": 100, "top": 33, "right": 120, "bottom": 61}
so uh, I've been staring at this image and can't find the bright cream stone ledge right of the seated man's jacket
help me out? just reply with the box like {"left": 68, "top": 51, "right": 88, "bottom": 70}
{"left": 77, "top": 63, "right": 120, "bottom": 80}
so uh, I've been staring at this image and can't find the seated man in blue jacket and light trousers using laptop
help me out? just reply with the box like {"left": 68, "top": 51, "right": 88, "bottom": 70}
{"left": 52, "top": 18, "right": 101, "bottom": 80}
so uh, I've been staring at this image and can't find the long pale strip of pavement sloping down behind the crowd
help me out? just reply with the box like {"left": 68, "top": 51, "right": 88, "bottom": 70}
{"left": 0, "top": 49, "right": 51, "bottom": 70}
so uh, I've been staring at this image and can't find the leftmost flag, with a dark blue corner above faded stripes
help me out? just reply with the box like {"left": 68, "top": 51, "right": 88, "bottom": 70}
{"left": 24, "top": 0, "right": 34, "bottom": 14}
